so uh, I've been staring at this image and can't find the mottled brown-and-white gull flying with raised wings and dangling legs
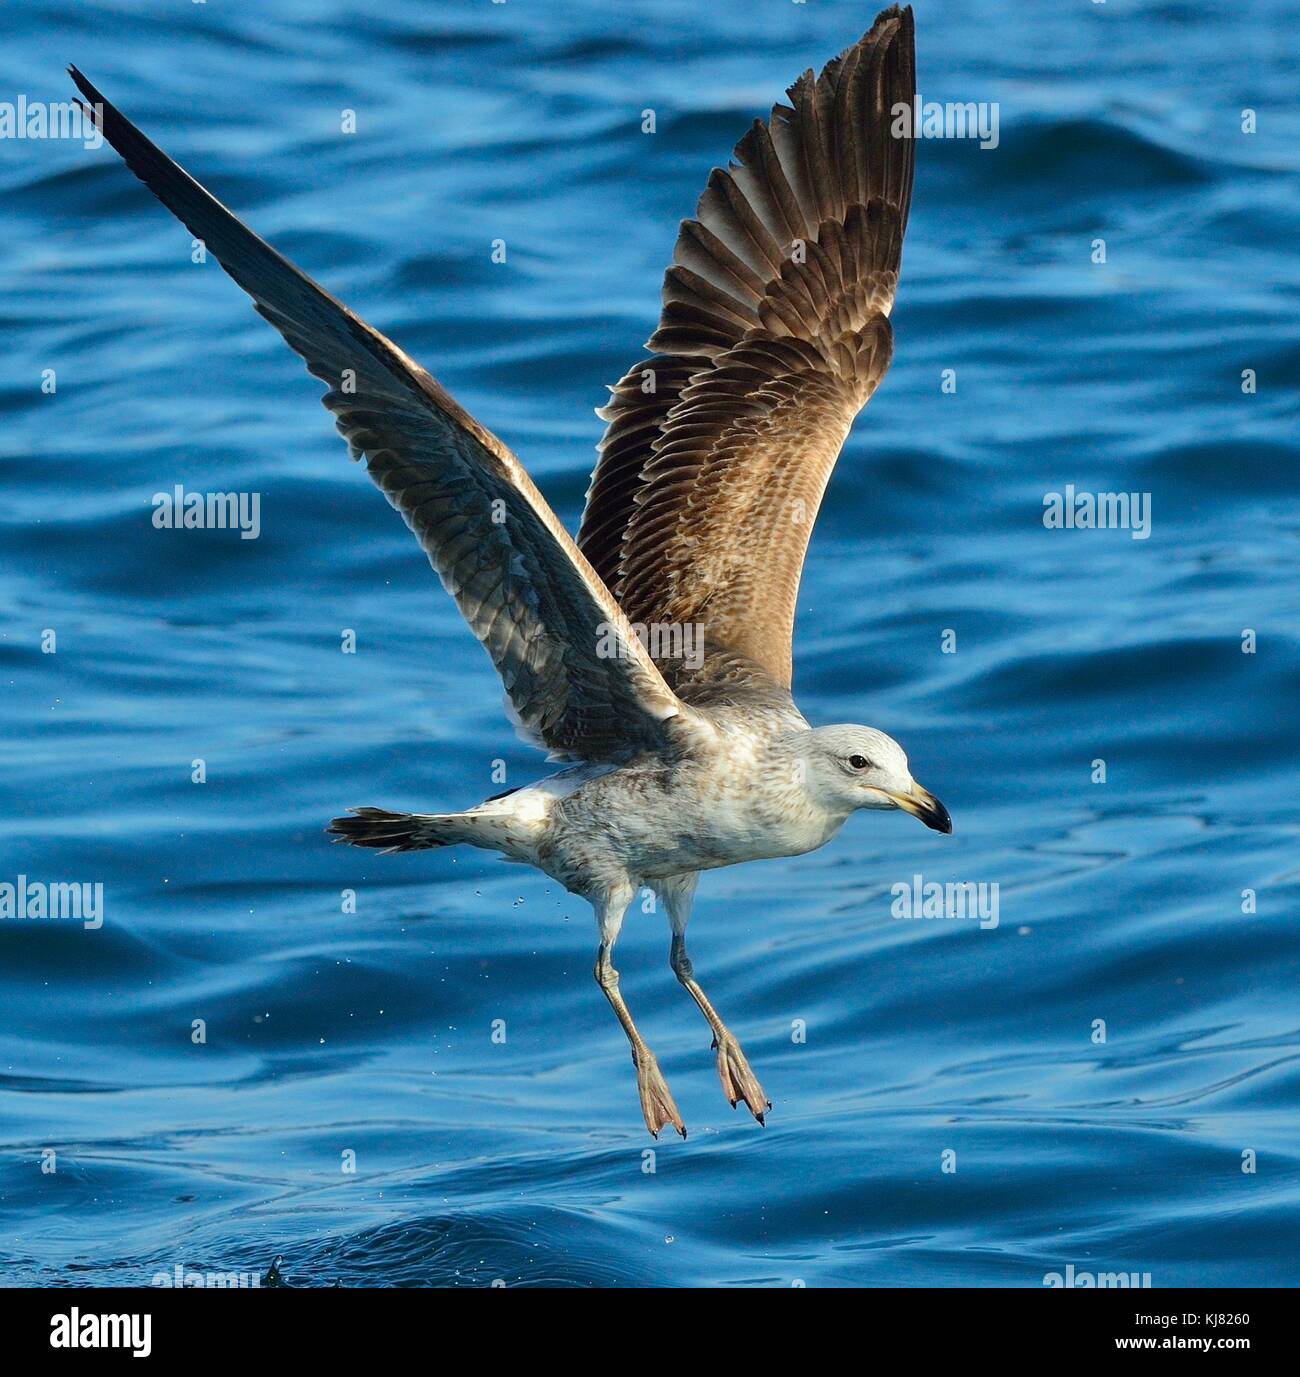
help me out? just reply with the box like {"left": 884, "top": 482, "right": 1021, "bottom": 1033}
{"left": 72, "top": 6, "right": 952, "bottom": 1137}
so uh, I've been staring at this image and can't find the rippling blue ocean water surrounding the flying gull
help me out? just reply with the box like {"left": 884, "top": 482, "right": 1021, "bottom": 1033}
{"left": 0, "top": 0, "right": 1300, "bottom": 1286}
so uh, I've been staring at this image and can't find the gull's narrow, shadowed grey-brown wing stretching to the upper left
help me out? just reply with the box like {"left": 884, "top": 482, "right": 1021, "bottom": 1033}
{"left": 72, "top": 67, "right": 683, "bottom": 760}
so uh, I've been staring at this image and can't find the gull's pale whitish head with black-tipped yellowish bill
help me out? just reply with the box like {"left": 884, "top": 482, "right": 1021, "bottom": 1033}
{"left": 799, "top": 726, "right": 953, "bottom": 832}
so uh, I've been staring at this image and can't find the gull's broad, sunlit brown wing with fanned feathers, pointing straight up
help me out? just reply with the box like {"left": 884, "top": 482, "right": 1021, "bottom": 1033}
{"left": 578, "top": 6, "right": 916, "bottom": 687}
